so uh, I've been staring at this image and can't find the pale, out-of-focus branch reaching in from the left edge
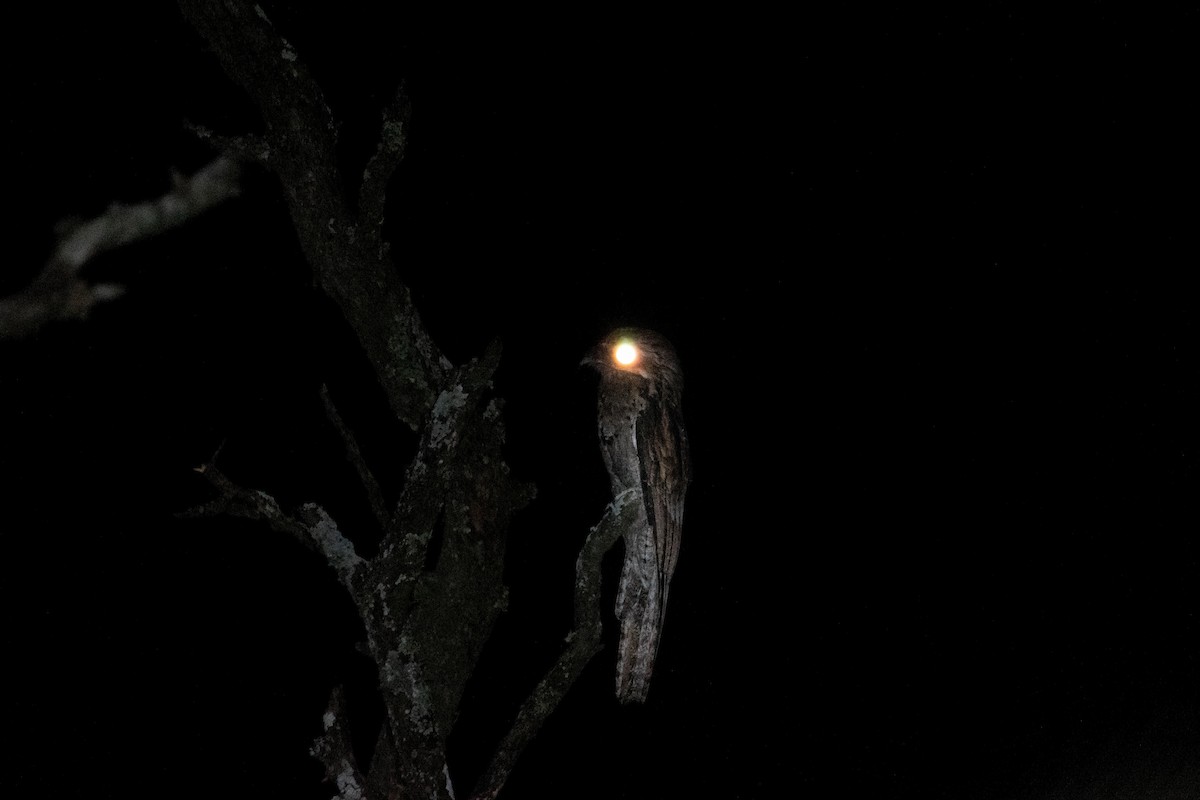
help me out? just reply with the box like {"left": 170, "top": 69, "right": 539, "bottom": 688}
{"left": 0, "top": 156, "right": 240, "bottom": 338}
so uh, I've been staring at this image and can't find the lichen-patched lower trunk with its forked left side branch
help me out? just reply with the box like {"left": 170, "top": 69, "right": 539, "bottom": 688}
{"left": 180, "top": 343, "right": 532, "bottom": 796}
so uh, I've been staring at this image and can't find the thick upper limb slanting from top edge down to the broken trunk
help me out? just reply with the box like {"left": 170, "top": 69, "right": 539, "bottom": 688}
{"left": 179, "top": 0, "right": 451, "bottom": 431}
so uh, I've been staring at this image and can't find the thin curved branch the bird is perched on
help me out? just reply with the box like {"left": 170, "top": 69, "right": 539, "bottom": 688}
{"left": 472, "top": 489, "right": 642, "bottom": 800}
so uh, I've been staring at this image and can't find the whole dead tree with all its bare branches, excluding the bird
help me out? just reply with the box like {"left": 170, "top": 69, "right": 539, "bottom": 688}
{"left": 11, "top": 0, "right": 637, "bottom": 800}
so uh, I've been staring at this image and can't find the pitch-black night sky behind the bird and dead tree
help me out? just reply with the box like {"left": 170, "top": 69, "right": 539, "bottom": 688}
{"left": 0, "top": 2, "right": 1200, "bottom": 800}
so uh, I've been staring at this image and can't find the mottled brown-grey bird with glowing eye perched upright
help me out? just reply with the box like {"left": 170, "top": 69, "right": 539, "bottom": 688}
{"left": 583, "top": 327, "right": 691, "bottom": 703}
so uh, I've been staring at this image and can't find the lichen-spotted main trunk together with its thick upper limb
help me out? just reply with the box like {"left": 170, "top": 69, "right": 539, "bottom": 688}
{"left": 172, "top": 0, "right": 544, "bottom": 799}
